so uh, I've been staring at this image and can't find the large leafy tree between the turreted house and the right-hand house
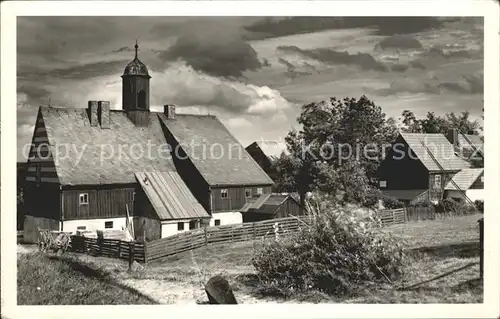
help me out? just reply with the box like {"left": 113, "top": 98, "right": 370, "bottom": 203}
{"left": 277, "top": 96, "right": 397, "bottom": 208}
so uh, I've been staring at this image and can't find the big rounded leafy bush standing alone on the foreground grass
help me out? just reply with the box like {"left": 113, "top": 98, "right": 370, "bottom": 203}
{"left": 252, "top": 207, "right": 406, "bottom": 296}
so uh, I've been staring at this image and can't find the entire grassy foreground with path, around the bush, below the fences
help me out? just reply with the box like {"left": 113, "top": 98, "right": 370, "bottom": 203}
{"left": 18, "top": 215, "right": 483, "bottom": 304}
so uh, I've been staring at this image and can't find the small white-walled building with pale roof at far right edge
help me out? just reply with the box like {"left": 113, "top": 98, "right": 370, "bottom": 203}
{"left": 445, "top": 168, "right": 485, "bottom": 202}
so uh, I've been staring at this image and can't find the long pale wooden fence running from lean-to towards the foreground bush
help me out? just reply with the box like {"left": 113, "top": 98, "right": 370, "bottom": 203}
{"left": 145, "top": 217, "right": 310, "bottom": 262}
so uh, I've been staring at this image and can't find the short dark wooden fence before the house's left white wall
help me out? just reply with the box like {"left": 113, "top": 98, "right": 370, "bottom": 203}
{"left": 69, "top": 236, "right": 146, "bottom": 262}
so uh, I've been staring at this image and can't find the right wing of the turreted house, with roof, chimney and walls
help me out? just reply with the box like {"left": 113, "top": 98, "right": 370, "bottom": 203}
{"left": 159, "top": 107, "right": 273, "bottom": 226}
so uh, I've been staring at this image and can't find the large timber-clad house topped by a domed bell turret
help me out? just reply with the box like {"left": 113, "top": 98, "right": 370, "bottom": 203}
{"left": 24, "top": 45, "right": 273, "bottom": 240}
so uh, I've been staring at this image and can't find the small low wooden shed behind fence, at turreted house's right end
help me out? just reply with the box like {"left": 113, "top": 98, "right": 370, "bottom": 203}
{"left": 241, "top": 194, "right": 300, "bottom": 223}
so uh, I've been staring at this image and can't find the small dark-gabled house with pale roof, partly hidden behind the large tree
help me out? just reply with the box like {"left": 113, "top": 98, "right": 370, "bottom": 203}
{"left": 246, "top": 141, "right": 286, "bottom": 184}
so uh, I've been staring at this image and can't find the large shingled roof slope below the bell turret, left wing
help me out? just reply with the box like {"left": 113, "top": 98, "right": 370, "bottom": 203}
{"left": 40, "top": 106, "right": 175, "bottom": 185}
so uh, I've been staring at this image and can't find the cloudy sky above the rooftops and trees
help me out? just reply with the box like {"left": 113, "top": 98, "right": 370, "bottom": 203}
{"left": 17, "top": 17, "right": 483, "bottom": 160}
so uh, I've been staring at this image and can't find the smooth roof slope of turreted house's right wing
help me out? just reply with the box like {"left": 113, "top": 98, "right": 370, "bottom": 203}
{"left": 159, "top": 114, "right": 273, "bottom": 186}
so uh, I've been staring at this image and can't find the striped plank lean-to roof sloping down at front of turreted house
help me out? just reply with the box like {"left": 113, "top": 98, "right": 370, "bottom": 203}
{"left": 135, "top": 171, "right": 210, "bottom": 220}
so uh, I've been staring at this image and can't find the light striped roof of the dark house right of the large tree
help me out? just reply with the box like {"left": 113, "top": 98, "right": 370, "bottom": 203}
{"left": 401, "top": 133, "right": 470, "bottom": 172}
